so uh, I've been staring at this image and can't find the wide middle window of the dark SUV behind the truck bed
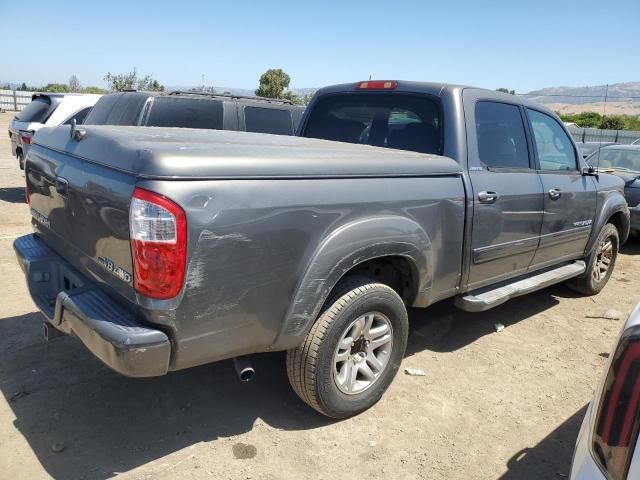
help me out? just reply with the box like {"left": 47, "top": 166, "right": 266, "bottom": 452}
{"left": 146, "top": 97, "right": 223, "bottom": 130}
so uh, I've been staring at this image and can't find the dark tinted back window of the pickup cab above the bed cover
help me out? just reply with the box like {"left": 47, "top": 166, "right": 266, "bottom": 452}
{"left": 304, "top": 94, "right": 442, "bottom": 154}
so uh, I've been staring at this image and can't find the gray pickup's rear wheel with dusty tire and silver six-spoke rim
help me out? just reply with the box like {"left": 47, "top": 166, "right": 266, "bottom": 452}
{"left": 287, "top": 277, "right": 409, "bottom": 418}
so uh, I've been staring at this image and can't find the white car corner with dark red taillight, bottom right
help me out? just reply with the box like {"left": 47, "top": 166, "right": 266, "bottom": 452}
{"left": 570, "top": 304, "right": 640, "bottom": 480}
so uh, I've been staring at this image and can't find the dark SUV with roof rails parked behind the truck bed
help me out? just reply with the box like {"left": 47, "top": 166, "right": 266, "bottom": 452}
{"left": 85, "top": 91, "right": 304, "bottom": 135}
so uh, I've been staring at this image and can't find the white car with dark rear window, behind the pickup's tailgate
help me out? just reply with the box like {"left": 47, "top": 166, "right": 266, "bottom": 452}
{"left": 9, "top": 93, "right": 102, "bottom": 169}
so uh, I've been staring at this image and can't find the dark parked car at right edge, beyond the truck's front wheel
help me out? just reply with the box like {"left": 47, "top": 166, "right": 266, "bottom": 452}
{"left": 586, "top": 145, "right": 640, "bottom": 237}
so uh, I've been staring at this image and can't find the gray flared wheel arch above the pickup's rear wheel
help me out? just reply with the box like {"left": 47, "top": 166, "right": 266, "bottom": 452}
{"left": 273, "top": 216, "right": 432, "bottom": 350}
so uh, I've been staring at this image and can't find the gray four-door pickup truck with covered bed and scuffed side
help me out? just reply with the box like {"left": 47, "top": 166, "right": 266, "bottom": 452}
{"left": 14, "top": 81, "right": 629, "bottom": 418}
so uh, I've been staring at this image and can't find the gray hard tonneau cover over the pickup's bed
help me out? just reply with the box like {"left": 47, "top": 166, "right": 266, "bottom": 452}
{"left": 34, "top": 125, "right": 462, "bottom": 179}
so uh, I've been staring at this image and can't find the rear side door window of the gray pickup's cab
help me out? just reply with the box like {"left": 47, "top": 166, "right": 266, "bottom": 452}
{"left": 475, "top": 101, "right": 530, "bottom": 168}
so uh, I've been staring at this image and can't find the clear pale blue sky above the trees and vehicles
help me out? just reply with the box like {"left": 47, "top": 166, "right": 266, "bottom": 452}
{"left": 0, "top": 0, "right": 640, "bottom": 92}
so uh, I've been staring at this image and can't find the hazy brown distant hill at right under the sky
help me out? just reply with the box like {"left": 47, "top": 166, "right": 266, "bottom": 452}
{"left": 525, "top": 82, "right": 640, "bottom": 105}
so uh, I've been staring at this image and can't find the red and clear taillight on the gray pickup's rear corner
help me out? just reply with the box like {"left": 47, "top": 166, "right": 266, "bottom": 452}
{"left": 129, "top": 188, "right": 187, "bottom": 299}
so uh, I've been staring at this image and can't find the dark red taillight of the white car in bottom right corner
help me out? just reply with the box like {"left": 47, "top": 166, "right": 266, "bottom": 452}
{"left": 593, "top": 327, "right": 640, "bottom": 480}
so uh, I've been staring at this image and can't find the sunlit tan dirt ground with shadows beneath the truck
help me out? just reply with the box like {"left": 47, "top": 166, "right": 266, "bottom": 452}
{"left": 0, "top": 109, "right": 640, "bottom": 480}
